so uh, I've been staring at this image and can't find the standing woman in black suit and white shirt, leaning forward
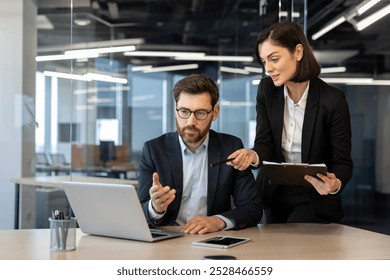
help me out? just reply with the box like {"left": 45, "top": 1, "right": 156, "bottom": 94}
{"left": 227, "top": 22, "right": 352, "bottom": 223}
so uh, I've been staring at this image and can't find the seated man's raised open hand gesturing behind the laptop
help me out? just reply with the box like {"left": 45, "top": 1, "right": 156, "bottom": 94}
{"left": 149, "top": 172, "right": 176, "bottom": 214}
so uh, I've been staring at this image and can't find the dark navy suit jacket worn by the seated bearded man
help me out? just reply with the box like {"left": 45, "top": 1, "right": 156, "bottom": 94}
{"left": 138, "top": 130, "right": 262, "bottom": 229}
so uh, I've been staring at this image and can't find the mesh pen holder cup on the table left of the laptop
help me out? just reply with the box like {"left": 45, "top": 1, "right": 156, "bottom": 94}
{"left": 49, "top": 218, "right": 76, "bottom": 252}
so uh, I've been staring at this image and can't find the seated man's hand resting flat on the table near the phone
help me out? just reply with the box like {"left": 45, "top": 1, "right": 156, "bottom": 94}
{"left": 183, "top": 216, "right": 226, "bottom": 234}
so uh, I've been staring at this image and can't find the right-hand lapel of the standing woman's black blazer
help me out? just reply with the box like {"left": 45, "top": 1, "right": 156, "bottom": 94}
{"left": 302, "top": 79, "right": 320, "bottom": 163}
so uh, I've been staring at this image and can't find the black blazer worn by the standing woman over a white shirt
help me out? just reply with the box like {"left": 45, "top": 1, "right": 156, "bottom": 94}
{"left": 253, "top": 77, "right": 353, "bottom": 222}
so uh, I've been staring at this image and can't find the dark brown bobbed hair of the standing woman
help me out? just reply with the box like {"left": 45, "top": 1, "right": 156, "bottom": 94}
{"left": 256, "top": 22, "right": 321, "bottom": 83}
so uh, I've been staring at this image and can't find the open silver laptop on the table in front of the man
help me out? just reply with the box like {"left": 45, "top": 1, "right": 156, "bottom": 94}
{"left": 62, "top": 181, "right": 184, "bottom": 242}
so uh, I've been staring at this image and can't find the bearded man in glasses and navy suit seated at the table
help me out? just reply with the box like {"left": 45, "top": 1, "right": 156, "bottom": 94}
{"left": 138, "top": 74, "right": 262, "bottom": 234}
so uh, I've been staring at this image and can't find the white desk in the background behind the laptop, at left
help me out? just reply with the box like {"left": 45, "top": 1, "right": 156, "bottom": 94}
{"left": 11, "top": 175, "right": 138, "bottom": 229}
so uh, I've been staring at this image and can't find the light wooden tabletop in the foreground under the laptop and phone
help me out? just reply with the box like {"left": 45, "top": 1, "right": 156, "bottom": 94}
{"left": 0, "top": 224, "right": 390, "bottom": 260}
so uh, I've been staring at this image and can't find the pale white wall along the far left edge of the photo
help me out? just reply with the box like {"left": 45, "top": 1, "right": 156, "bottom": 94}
{"left": 0, "top": 0, "right": 37, "bottom": 229}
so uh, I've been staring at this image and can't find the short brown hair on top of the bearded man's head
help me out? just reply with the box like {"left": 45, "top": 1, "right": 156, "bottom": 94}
{"left": 173, "top": 74, "right": 219, "bottom": 108}
